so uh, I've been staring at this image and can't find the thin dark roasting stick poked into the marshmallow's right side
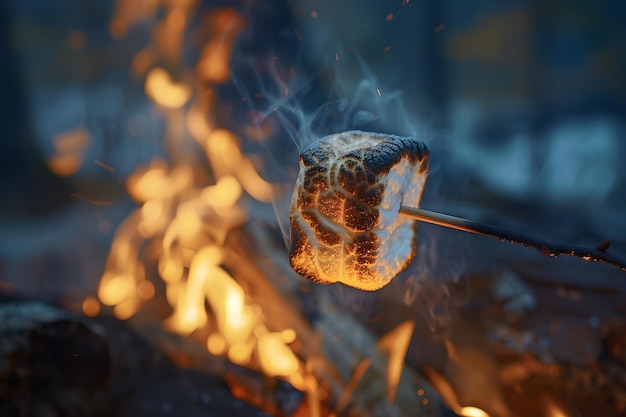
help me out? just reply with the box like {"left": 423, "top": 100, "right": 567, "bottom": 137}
{"left": 400, "top": 206, "right": 626, "bottom": 272}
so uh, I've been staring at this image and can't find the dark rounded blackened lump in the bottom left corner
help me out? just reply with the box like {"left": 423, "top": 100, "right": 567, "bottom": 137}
{"left": 0, "top": 302, "right": 111, "bottom": 417}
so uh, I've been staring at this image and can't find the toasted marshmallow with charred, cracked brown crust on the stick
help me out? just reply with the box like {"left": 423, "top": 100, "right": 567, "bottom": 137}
{"left": 289, "top": 131, "right": 428, "bottom": 291}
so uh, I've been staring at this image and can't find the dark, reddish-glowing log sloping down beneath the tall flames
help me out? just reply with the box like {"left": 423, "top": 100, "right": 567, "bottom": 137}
{"left": 124, "top": 309, "right": 303, "bottom": 416}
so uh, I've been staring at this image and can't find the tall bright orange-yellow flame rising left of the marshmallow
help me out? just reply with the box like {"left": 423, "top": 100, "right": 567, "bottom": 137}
{"left": 83, "top": 0, "right": 304, "bottom": 390}
